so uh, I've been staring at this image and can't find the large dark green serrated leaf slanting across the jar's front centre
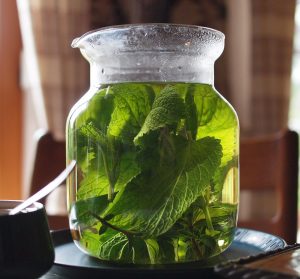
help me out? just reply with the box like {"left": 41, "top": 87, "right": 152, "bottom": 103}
{"left": 107, "top": 138, "right": 222, "bottom": 238}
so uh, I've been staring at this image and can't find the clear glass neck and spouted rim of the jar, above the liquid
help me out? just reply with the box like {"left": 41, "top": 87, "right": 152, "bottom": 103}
{"left": 72, "top": 23, "right": 225, "bottom": 84}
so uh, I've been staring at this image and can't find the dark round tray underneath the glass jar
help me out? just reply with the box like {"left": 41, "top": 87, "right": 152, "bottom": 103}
{"left": 42, "top": 228, "right": 286, "bottom": 279}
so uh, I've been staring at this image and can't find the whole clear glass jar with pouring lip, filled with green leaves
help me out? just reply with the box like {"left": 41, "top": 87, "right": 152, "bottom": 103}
{"left": 67, "top": 24, "right": 239, "bottom": 264}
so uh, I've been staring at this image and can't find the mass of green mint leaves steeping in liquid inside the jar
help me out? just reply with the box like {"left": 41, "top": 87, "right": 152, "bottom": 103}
{"left": 73, "top": 83, "right": 237, "bottom": 264}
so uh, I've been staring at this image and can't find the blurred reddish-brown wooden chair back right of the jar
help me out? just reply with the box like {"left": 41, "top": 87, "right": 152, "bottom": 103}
{"left": 238, "top": 130, "right": 299, "bottom": 244}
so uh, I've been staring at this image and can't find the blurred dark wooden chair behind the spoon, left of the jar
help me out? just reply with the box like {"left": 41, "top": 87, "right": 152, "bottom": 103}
{"left": 30, "top": 133, "right": 69, "bottom": 230}
